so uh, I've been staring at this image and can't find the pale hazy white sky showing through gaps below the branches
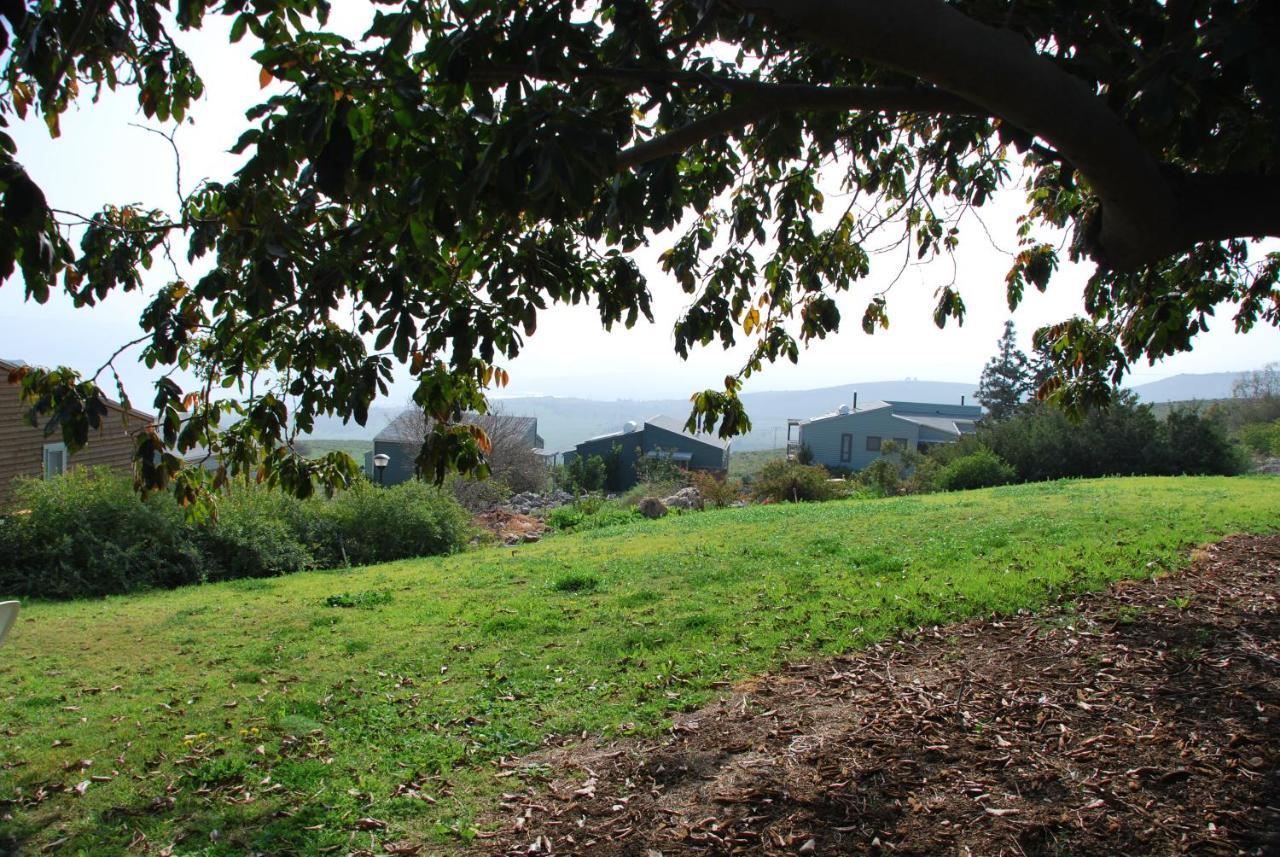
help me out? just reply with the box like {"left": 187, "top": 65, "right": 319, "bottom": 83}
{"left": 0, "top": 3, "right": 1280, "bottom": 404}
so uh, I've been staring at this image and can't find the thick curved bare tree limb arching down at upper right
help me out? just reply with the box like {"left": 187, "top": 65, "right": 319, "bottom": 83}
{"left": 735, "top": 0, "right": 1185, "bottom": 269}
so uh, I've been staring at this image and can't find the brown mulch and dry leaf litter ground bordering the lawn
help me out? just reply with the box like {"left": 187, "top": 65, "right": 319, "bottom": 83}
{"left": 484, "top": 536, "right": 1280, "bottom": 857}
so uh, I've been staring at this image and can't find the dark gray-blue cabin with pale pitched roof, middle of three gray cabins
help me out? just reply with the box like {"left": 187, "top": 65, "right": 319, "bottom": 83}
{"left": 561, "top": 417, "right": 730, "bottom": 491}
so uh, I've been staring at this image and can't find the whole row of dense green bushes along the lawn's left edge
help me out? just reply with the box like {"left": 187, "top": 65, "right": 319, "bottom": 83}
{"left": 0, "top": 468, "right": 470, "bottom": 599}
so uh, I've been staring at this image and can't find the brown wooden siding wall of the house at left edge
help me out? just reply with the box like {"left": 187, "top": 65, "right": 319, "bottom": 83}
{"left": 0, "top": 377, "right": 148, "bottom": 508}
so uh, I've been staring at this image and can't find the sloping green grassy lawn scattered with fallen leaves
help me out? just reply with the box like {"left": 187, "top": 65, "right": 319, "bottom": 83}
{"left": 0, "top": 477, "right": 1280, "bottom": 856}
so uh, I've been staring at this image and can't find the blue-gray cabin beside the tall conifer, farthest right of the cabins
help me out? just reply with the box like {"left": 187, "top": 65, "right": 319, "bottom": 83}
{"left": 787, "top": 399, "right": 982, "bottom": 471}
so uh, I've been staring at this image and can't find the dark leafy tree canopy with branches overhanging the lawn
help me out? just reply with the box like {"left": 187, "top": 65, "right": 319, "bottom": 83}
{"left": 0, "top": 0, "right": 1280, "bottom": 496}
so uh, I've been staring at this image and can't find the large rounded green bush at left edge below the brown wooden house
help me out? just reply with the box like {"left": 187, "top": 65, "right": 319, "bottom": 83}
{"left": 0, "top": 468, "right": 205, "bottom": 599}
